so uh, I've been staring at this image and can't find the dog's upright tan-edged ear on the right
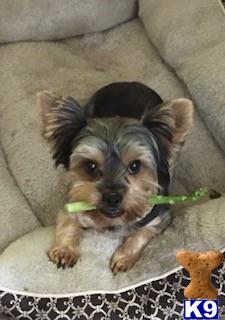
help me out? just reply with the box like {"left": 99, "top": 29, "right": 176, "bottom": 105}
{"left": 142, "top": 99, "right": 193, "bottom": 160}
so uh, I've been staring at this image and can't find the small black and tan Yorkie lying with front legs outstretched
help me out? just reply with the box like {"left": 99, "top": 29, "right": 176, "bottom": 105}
{"left": 38, "top": 82, "right": 193, "bottom": 273}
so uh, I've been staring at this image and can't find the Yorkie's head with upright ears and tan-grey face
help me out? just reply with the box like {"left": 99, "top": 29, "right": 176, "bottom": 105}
{"left": 38, "top": 92, "right": 193, "bottom": 220}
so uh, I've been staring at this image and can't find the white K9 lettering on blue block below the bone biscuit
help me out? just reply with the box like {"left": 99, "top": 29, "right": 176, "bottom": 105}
{"left": 184, "top": 299, "right": 218, "bottom": 320}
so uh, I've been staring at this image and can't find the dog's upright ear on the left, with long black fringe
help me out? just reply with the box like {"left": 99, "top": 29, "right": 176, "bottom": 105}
{"left": 37, "top": 91, "right": 87, "bottom": 169}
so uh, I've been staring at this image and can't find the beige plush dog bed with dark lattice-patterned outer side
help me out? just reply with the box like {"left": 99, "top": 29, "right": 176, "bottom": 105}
{"left": 0, "top": 0, "right": 225, "bottom": 319}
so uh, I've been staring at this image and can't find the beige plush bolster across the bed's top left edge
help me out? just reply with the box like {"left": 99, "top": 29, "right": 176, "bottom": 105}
{"left": 0, "top": 0, "right": 137, "bottom": 43}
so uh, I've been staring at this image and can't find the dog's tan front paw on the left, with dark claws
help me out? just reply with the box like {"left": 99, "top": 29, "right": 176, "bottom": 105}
{"left": 48, "top": 246, "right": 79, "bottom": 269}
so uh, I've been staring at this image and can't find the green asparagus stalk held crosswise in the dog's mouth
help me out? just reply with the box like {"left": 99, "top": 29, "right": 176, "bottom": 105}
{"left": 65, "top": 187, "right": 220, "bottom": 213}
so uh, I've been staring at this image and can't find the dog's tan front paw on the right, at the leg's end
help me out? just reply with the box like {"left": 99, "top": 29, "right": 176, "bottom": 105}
{"left": 110, "top": 248, "right": 139, "bottom": 274}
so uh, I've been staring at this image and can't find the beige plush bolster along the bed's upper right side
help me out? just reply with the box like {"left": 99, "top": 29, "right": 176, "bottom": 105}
{"left": 139, "top": 0, "right": 225, "bottom": 154}
